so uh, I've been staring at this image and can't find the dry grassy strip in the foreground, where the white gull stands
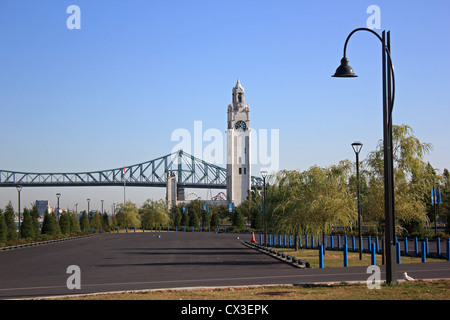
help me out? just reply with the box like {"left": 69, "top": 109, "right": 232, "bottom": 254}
{"left": 53, "top": 280, "right": 450, "bottom": 300}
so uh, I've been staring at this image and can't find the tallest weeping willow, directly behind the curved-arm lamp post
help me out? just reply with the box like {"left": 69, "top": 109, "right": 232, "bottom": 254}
{"left": 362, "top": 124, "right": 435, "bottom": 233}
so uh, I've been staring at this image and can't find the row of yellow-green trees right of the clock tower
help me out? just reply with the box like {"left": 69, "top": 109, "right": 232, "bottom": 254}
{"left": 240, "top": 125, "right": 450, "bottom": 237}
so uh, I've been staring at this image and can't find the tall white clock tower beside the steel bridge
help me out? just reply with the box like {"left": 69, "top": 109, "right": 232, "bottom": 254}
{"left": 226, "top": 79, "right": 251, "bottom": 206}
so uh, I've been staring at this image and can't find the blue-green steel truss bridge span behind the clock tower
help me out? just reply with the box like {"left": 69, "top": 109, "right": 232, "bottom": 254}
{"left": 0, "top": 150, "right": 262, "bottom": 189}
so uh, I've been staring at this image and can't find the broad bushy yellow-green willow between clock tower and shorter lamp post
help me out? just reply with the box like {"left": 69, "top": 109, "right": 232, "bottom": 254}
{"left": 267, "top": 161, "right": 357, "bottom": 249}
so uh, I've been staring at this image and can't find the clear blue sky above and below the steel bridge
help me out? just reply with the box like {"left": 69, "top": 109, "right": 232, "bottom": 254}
{"left": 0, "top": 0, "right": 450, "bottom": 214}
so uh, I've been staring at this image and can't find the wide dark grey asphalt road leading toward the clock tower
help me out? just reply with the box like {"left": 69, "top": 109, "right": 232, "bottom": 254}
{"left": 0, "top": 232, "right": 450, "bottom": 299}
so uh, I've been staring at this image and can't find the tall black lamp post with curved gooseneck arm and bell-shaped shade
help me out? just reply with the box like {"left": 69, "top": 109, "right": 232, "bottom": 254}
{"left": 333, "top": 28, "right": 397, "bottom": 284}
